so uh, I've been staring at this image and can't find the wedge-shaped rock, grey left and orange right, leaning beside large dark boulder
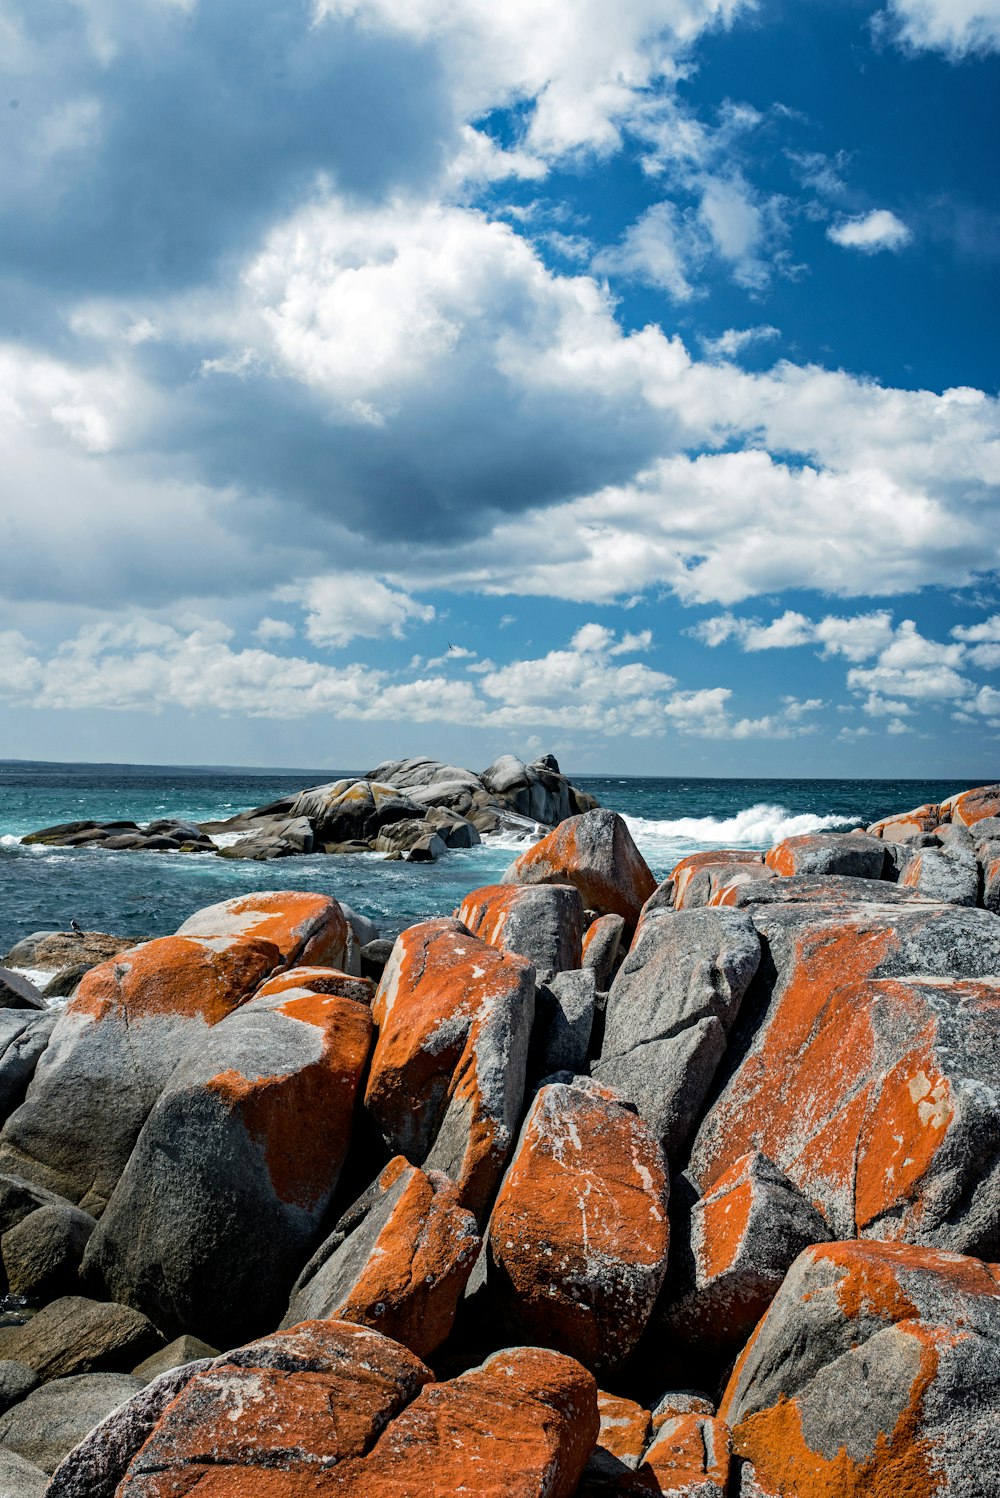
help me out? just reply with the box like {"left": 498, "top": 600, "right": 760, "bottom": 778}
{"left": 281, "top": 1155, "right": 482, "bottom": 1357}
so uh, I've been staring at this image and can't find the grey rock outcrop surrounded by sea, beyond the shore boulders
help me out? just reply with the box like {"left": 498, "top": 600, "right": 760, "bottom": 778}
{"left": 21, "top": 753, "right": 597, "bottom": 863}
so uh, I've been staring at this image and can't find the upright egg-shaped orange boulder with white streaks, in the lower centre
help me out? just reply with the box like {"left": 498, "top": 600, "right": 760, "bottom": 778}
{"left": 488, "top": 1077, "right": 669, "bottom": 1371}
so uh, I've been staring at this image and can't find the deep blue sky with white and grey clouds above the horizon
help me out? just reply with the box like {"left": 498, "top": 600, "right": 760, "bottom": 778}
{"left": 0, "top": 0, "right": 1000, "bottom": 779}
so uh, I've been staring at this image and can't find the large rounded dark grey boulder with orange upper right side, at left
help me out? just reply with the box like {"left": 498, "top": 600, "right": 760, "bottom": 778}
{"left": 84, "top": 992, "right": 371, "bottom": 1347}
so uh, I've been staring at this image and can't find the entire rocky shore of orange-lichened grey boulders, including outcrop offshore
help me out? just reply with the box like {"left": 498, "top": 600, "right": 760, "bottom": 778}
{"left": 0, "top": 784, "right": 1000, "bottom": 1498}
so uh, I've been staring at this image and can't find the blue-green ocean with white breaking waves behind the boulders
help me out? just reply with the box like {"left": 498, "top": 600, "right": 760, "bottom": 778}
{"left": 0, "top": 761, "right": 979, "bottom": 953}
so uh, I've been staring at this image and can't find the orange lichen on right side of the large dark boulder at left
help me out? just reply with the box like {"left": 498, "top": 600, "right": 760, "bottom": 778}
{"left": 205, "top": 993, "right": 371, "bottom": 1212}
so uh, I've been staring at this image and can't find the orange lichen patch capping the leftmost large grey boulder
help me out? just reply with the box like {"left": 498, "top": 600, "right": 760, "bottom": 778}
{"left": 66, "top": 936, "right": 281, "bottom": 1025}
